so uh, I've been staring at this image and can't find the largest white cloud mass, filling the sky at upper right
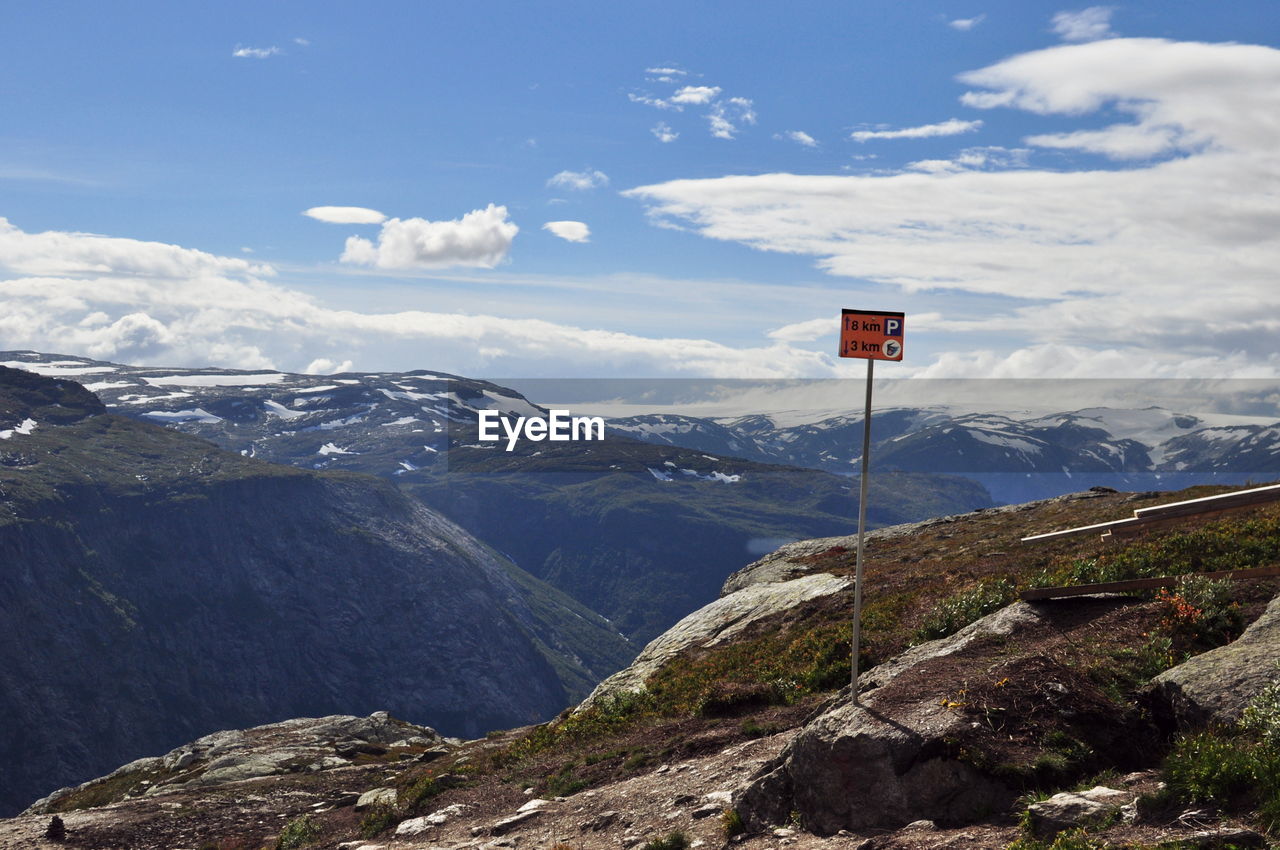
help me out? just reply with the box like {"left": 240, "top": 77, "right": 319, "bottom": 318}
{"left": 626, "top": 38, "right": 1280, "bottom": 375}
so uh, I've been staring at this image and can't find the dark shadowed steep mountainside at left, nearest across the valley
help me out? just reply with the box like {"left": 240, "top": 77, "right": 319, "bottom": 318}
{"left": 0, "top": 369, "right": 630, "bottom": 810}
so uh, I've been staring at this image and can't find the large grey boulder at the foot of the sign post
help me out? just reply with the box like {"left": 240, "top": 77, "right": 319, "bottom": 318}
{"left": 733, "top": 598, "right": 1128, "bottom": 835}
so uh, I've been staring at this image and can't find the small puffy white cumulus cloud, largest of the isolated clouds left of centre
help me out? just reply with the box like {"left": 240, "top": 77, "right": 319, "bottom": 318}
{"left": 340, "top": 204, "right": 520, "bottom": 269}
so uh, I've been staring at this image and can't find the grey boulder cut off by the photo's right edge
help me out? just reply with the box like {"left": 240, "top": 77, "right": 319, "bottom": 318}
{"left": 1152, "top": 597, "right": 1280, "bottom": 727}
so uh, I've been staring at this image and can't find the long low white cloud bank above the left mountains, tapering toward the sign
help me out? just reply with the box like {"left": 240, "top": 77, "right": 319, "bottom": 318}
{"left": 0, "top": 221, "right": 837, "bottom": 378}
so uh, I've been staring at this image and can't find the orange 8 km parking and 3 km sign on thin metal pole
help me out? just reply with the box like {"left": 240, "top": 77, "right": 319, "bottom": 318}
{"left": 840, "top": 310, "right": 905, "bottom": 703}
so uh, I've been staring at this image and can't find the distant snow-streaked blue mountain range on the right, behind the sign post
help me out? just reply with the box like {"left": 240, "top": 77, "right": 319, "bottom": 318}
{"left": 609, "top": 406, "right": 1280, "bottom": 503}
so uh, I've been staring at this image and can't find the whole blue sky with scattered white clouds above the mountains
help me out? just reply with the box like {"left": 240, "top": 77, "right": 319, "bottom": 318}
{"left": 0, "top": 0, "right": 1280, "bottom": 379}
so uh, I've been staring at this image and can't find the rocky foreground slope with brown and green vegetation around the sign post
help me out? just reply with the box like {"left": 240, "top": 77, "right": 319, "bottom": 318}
{"left": 0, "top": 481, "right": 1280, "bottom": 850}
